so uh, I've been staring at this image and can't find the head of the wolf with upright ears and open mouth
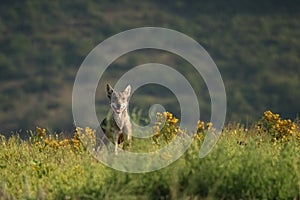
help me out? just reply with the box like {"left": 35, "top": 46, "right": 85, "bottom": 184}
{"left": 106, "top": 84, "right": 131, "bottom": 114}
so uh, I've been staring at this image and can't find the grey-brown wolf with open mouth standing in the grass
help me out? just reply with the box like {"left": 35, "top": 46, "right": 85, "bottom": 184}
{"left": 96, "top": 84, "right": 132, "bottom": 155}
